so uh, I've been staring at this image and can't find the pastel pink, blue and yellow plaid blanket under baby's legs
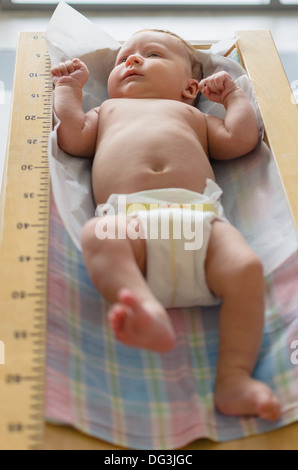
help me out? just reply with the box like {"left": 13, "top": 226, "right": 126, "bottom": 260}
{"left": 46, "top": 193, "right": 298, "bottom": 449}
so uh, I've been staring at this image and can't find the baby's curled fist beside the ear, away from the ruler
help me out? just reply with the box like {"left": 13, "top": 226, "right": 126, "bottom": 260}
{"left": 199, "top": 72, "right": 238, "bottom": 104}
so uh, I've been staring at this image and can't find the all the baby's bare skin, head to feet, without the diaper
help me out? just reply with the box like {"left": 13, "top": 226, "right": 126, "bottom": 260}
{"left": 52, "top": 31, "right": 280, "bottom": 421}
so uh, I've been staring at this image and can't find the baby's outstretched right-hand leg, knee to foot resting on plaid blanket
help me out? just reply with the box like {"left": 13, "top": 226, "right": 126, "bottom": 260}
{"left": 206, "top": 221, "right": 280, "bottom": 421}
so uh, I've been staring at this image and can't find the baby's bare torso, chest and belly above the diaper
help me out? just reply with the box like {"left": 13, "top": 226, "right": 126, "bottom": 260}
{"left": 93, "top": 99, "right": 214, "bottom": 204}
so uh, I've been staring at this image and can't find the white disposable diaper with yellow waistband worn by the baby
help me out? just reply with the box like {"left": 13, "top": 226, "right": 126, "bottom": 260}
{"left": 96, "top": 179, "right": 227, "bottom": 308}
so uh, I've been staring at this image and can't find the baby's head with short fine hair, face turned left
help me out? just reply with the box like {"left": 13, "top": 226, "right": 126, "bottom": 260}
{"left": 108, "top": 29, "right": 202, "bottom": 105}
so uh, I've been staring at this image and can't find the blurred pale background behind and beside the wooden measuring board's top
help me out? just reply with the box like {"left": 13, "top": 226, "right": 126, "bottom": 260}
{"left": 0, "top": 0, "right": 298, "bottom": 192}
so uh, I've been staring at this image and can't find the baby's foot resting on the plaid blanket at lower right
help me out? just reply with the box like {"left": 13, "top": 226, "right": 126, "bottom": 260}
{"left": 215, "top": 373, "right": 280, "bottom": 421}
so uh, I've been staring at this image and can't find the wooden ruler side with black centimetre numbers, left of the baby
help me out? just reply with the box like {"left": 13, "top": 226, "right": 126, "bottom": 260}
{"left": 0, "top": 33, "right": 52, "bottom": 450}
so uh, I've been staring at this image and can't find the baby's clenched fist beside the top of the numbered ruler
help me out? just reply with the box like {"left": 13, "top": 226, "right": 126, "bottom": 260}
{"left": 51, "top": 59, "right": 89, "bottom": 88}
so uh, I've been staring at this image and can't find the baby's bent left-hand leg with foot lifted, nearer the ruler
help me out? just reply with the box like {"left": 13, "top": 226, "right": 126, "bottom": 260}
{"left": 82, "top": 216, "right": 175, "bottom": 352}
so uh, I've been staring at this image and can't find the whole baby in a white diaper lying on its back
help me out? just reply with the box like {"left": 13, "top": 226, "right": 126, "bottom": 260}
{"left": 52, "top": 30, "right": 280, "bottom": 421}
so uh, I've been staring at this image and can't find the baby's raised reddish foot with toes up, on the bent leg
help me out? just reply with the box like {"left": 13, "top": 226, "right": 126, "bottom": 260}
{"left": 109, "top": 289, "right": 175, "bottom": 353}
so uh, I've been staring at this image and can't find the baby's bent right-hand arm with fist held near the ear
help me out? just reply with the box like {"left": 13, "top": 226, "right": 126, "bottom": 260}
{"left": 199, "top": 72, "right": 259, "bottom": 160}
